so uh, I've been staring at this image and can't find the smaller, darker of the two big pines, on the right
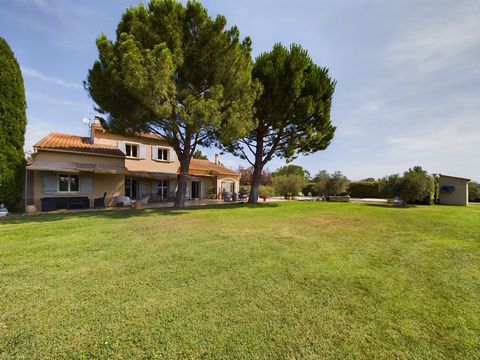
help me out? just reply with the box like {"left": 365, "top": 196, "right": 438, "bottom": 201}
{"left": 226, "top": 44, "right": 335, "bottom": 203}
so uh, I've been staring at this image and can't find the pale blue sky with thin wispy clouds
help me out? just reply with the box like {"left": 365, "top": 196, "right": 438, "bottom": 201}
{"left": 0, "top": 0, "right": 480, "bottom": 180}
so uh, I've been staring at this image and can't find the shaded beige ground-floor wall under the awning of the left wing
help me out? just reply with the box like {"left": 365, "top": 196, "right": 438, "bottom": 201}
{"left": 28, "top": 170, "right": 125, "bottom": 210}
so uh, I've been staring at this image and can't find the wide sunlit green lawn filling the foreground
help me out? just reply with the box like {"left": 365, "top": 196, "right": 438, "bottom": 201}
{"left": 0, "top": 202, "right": 480, "bottom": 359}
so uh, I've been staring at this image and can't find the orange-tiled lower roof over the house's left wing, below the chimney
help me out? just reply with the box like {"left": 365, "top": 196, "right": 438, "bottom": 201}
{"left": 33, "top": 133, "right": 125, "bottom": 157}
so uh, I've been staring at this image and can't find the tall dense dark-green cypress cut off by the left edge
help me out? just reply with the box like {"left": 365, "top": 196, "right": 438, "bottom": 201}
{"left": 0, "top": 37, "right": 27, "bottom": 211}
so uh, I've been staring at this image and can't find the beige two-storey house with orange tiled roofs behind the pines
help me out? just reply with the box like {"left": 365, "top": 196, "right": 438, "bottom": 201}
{"left": 27, "top": 120, "right": 240, "bottom": 211}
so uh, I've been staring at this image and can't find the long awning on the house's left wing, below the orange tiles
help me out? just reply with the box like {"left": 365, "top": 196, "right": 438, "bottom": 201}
{"left": 27, "top": 161, "right": 128, "bottom": 174}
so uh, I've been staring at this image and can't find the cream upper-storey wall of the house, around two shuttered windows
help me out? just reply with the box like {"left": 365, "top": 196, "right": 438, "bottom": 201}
{"left": 92, "top": 128, "right": 180, "bottom": 174}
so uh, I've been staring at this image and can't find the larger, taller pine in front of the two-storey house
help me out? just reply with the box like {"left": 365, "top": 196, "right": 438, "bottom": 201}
{"left": 85, "top": 0, "right": 259, "bottom": 207}
